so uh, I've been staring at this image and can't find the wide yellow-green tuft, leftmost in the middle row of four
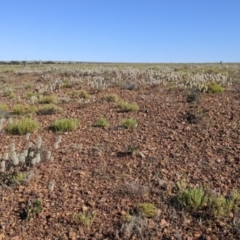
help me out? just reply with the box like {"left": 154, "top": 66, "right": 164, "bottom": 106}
{"left": 6, "top": 118, "right": 39, "bottom": 135}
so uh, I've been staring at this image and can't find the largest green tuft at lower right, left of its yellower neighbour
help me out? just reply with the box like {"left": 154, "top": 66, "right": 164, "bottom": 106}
{"left": 177, "top": 187, "right": 207, "bottom": 210}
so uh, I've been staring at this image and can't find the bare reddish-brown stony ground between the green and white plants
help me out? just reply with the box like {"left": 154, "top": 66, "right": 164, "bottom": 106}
{"left": 0, "top": 64, "right": 240, "bottom": 240}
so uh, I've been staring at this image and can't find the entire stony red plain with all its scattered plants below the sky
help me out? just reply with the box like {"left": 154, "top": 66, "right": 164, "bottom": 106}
{"left": 0, "top": 62, "right": 240, "bottom": 240}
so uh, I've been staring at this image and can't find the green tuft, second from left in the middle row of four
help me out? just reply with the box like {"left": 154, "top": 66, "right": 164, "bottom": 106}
{"left": 53, "top": 118, "right": 78, "bottom": 132}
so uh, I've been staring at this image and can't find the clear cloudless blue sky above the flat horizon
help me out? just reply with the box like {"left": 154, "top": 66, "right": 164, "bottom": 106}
{"left": 0, "top": 0, "right": 240, "bottom": 63}
